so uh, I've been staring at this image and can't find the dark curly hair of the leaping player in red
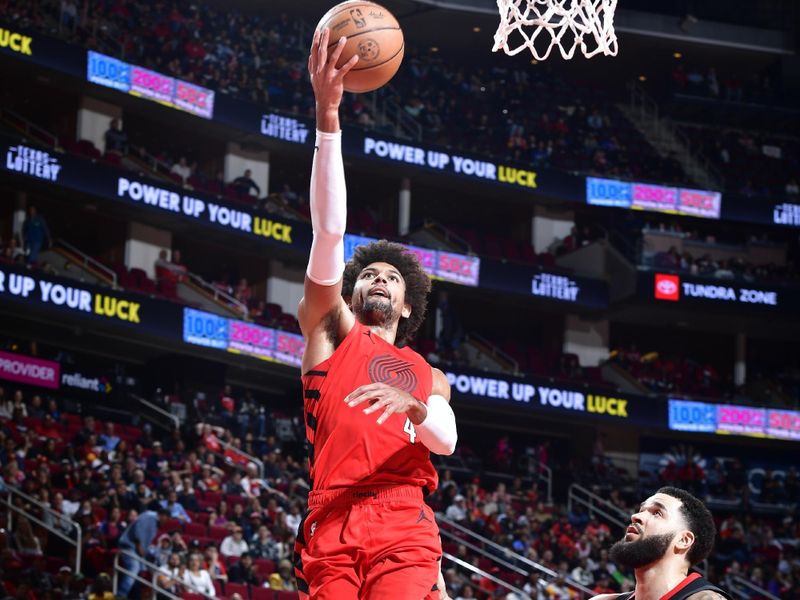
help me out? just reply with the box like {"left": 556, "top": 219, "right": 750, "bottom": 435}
{"left": 342, "top": 240, "right": 431, "bottom": 345}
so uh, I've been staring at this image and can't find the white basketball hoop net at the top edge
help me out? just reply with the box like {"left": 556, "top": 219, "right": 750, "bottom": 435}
{"left": 492, "top": 0, "right": 617, "bottom": 60}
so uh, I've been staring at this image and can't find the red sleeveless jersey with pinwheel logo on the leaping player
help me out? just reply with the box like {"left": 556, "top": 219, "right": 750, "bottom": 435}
{"left": 302, "top": 321, "right": 438, "bottom": 492}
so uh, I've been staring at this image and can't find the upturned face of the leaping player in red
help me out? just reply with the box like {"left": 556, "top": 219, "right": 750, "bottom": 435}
{"left": 351, "top": 262, "right": 411, "bottom": 325}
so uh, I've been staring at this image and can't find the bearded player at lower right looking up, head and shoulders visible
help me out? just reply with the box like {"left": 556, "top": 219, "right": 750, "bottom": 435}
{"left": 592, "top": 487, "right": 733, "bottom": 600}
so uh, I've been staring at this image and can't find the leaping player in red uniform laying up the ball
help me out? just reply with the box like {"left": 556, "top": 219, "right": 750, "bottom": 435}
{"left": 295, "top": 30, "right": 457, "bottom": 600}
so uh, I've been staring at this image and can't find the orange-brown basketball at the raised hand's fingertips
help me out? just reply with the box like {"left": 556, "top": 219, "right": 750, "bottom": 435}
{"left": 317, "top": 0, "right": 405, "bottom": 93}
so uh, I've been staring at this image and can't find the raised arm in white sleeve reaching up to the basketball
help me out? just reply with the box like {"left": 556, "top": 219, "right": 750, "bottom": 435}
{"left": 297, "top": 29, "right": 358, "bottom": 368}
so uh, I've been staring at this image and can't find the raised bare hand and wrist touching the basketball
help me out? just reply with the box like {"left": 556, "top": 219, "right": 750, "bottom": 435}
{"left": 308, "top": 28, "right": 358, "bottom": 112}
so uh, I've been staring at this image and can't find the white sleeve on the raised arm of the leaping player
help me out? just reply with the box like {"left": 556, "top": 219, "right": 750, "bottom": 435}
{"left": 306, "top": 130, "right": 347, "bottom": 285}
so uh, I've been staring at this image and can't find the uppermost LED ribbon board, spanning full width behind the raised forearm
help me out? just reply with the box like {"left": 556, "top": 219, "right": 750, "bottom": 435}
{"left": 0, "top": 23, "right": 800, "bottom": 227}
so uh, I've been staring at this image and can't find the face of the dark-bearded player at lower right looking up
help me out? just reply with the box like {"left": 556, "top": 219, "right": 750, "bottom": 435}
{"left": 610, "top": 494, "right": 693, "bottom": 569}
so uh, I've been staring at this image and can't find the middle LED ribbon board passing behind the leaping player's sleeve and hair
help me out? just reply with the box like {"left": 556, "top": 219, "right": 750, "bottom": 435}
{"left": 0, "top": 134, "right": 608, "bottom": 300}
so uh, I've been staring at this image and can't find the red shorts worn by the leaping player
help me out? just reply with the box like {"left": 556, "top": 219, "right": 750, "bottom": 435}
{"left": 294, "top": 486, "right": 442, "bottom": 600}
